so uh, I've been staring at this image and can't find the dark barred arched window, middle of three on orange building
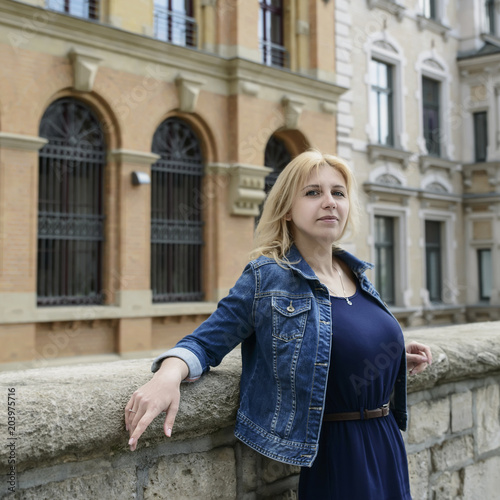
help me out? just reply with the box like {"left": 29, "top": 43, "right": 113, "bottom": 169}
{"left": 151, "top": 118, "right": 203, "bottom": 302}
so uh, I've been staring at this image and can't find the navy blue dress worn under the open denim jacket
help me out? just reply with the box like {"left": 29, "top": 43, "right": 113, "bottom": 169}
{"left": 299, "top": 286, "right": 411, "bottom": 500}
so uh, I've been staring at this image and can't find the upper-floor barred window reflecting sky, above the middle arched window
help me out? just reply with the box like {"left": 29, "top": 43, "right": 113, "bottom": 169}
{"left": 154, "top": 0, "right": 198, "bottom": 47}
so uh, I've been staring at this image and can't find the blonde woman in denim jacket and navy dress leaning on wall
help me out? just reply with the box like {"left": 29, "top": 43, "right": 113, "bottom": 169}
{"left": 125, "top": 151, "right": 432, "bottom": 500}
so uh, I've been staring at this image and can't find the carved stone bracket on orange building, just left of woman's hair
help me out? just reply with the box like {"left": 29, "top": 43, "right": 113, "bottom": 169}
{"left": 229, "top": 164, "right": 272, "bottom": 217}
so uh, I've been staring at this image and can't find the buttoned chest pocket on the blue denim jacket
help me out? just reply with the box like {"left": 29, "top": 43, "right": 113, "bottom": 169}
{"left": 271, "top": 297, "right": 311, "bottom": 342}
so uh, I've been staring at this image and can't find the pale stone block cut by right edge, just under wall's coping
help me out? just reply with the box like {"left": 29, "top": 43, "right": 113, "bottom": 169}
{"left": 476, "top": 384, "right": 500, "bottom": 454}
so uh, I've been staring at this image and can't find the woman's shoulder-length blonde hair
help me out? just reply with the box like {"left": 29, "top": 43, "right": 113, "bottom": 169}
{"left": 250, "top": 150, "right": 359, "bottom": 264}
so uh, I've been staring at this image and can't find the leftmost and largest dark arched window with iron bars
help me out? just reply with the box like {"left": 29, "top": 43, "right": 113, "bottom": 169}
{"left": 37, "top": 98, "right": 106, "bottom": 306}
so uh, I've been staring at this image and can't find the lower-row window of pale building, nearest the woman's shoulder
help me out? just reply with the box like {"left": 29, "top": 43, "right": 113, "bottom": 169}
{"left": 375, "top": 216, "right": 396, "bottom": 304}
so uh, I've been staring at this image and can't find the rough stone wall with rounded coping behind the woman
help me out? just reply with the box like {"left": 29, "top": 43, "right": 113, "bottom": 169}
{"left": 0, "top": 322, "right": 500, "bottom": 500}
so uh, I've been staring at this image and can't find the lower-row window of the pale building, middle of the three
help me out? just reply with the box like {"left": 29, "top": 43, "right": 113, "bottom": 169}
{"left": 425, "top": 220, "right": 443, "bottom": 302}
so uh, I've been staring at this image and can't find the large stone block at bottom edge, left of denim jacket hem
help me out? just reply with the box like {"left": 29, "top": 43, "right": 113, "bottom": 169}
{"left": 144, "top": 447, "right": 236, "bottom": 500}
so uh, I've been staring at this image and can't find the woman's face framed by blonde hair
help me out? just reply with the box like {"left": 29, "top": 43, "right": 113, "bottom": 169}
{"left": 286, "top": 165, "right": 349, "bottom": 245}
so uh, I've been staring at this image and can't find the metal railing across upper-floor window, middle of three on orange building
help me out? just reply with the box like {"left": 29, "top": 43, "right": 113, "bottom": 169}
{"left": 154, "top": 5, "right": 197, "bottom": 47}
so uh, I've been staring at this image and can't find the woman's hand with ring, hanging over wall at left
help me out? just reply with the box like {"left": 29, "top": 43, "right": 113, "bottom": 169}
{"left": 125, "top": 357, "right": 189, "bottom": 451}
